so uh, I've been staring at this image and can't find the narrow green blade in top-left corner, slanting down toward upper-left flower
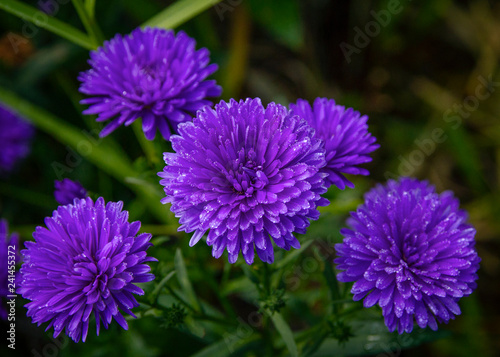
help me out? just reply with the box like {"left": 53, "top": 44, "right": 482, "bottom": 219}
{"left": 0, "top": 0, "right": 96, "bottom": 50}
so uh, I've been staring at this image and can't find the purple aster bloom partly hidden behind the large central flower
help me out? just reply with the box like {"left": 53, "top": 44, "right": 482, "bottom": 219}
{"left": 290, "top": 98, "right": 379, "bottom": 190}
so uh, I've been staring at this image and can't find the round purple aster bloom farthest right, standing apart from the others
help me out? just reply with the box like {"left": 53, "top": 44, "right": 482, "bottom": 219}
{"left": 335, "top": 178, "right": 480, "bottom": 333}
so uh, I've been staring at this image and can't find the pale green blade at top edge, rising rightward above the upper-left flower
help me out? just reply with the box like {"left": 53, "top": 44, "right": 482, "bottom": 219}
{"left": 142, "top": 0, "right": 222, "bottom": 29}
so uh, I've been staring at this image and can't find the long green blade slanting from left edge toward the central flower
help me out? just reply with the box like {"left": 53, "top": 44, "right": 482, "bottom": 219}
{"left": 0, "top": 88, "right": 171, "bottom": 223}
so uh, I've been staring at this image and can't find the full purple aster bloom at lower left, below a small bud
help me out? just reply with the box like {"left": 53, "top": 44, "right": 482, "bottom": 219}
{"left": 18, "top": 197, "right": 156, "bottom": 342}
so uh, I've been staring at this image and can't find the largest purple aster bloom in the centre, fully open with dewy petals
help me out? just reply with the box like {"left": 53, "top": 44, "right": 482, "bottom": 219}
{"left": 158, "top": 99, "right": 328, "bottom": 264}
